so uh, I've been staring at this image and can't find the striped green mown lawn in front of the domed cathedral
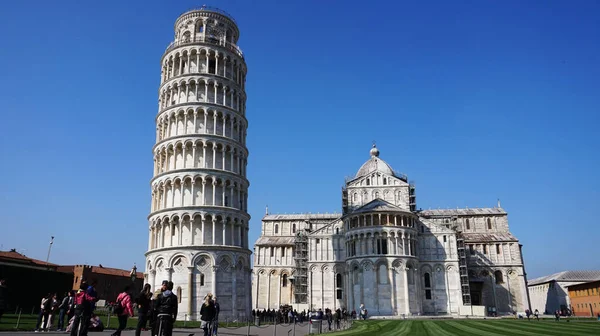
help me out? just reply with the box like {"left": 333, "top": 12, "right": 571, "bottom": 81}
{"left": 329, "top": 319, "right": 600, "bottom": 336}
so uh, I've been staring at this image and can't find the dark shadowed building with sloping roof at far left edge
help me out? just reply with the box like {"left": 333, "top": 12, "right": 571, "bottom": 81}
{"left": 0, "top": 249, "right": 73, "bottom": 312}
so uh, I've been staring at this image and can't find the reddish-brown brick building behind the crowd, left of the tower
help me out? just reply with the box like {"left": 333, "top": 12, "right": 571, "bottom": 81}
{"left": 58, "top": 265, "right": 144, "bottom": 302}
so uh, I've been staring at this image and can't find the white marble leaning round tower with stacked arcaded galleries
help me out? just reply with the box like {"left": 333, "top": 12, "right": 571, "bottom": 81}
{"left": 146, "top": 7, "right": 251, "bottom": 319}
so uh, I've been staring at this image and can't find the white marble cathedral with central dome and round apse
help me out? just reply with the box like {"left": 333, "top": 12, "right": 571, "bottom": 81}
{"left": 252, "top": 145, "right": 529, "bottom": 316}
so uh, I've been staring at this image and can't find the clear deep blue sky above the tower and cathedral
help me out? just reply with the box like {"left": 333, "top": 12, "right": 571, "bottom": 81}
{"left": 0, "top": 0, "right": 600, "bottom": 277}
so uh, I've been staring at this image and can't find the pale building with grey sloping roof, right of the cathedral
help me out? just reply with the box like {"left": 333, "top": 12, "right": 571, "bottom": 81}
{"left": 528, "top": 271, "right": 600, "bottom": 314}
